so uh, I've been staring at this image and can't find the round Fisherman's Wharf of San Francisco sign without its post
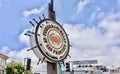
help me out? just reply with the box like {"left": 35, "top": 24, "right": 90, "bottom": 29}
{"left": 30, "top": 19, "right": 69, "bottom": 62}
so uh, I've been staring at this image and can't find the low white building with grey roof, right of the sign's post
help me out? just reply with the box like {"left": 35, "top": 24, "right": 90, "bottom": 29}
{"left": 63, "top": 60, "right": 108, "bottom": 74}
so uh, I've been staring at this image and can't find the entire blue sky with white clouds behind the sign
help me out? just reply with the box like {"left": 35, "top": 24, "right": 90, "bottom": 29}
{"left": 0, "top": 0, "right": 120, "bottom": 72}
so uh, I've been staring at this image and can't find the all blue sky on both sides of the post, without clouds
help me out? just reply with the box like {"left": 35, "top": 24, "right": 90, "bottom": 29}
{"left": 0, "top": 0, "right": 119, "bottom": 49}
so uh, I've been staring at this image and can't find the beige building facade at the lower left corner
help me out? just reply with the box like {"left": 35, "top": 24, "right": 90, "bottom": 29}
{"left": 0, "top": 54, "right": 8, "bottom": 74}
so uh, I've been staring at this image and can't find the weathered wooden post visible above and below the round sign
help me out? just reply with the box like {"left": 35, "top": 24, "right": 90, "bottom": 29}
{"left": 47, "top": 0, "right": 57, "bottom": 74}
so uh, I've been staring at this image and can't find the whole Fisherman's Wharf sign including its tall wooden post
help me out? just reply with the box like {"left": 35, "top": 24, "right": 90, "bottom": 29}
{"left": 26, "top": 0, "right": 70, "bottom": 74}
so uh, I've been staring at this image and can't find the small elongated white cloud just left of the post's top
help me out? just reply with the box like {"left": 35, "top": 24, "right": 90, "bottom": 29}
{"left": 23, "top": 5, "right": 47, "bottom": 17}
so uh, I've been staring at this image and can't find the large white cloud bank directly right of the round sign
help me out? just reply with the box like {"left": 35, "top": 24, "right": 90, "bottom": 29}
{"left": 64, "top": 13, "right": 120, "bottom": 66}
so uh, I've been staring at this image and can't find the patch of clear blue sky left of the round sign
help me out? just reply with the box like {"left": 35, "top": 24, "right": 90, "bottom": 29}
{"left": 0, "top": 0, "right": 48, "bottom": 49}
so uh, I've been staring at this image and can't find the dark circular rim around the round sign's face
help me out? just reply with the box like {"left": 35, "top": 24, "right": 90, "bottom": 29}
{"left": 35, "top": 19, "right": 70, "bottom": 62}
